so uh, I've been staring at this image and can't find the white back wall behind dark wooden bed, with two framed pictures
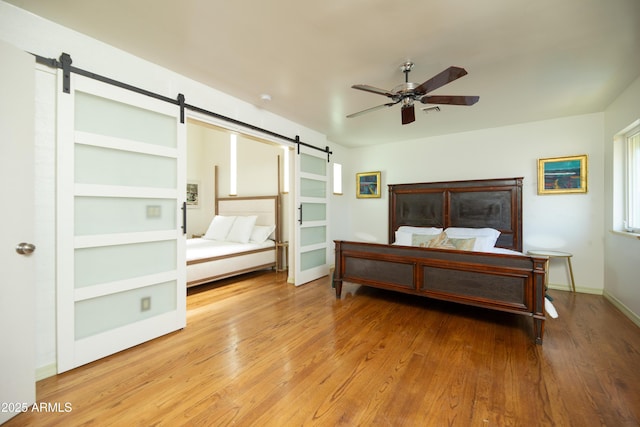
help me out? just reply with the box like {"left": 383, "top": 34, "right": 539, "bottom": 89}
{"left": 336, "top": 113, "right": 604, "bottom": 293}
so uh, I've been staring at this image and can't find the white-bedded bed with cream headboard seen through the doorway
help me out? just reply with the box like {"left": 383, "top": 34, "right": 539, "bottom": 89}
{"left": 187, "top": 196, "right": 280, "bottom": 287}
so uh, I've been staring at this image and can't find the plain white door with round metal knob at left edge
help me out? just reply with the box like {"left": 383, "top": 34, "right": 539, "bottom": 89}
{"left": 0, "top": 42, "right": 38, "bottom": 424}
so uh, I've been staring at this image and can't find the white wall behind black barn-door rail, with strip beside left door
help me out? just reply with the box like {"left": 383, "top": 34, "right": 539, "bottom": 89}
{"left": 0, "top": 1, "right": 327, "bottom": 378}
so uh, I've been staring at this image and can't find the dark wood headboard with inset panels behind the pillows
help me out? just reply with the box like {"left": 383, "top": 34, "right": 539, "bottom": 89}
{"left": 389, "top": 178, "right": 522, "bottom": 252}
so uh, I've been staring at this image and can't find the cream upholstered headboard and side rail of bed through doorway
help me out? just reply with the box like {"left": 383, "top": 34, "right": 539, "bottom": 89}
{"left": 187, "top": 196, "right": 281, "bottom": 287}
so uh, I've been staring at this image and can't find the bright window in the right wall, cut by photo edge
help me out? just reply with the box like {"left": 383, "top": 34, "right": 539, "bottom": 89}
{"left": 624, "top": 125, "right": 640, "bottom": 233}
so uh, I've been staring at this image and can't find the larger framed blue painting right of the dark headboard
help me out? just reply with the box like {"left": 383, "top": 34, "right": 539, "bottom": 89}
{"left": 538, "top": 154, "right": 587, "bottom": 194}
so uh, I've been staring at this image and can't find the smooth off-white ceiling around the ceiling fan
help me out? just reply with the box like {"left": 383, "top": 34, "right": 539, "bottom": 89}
{"left": 5, "top": 0, "right": 640, "bottom": 147}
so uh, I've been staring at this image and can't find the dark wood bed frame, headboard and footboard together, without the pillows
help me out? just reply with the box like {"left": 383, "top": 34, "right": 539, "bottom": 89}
{"left": 333, "top": 178, "right": 548, "bottom": 344}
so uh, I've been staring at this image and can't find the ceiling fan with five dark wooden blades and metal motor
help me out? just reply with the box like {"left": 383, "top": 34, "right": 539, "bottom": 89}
{"left": 347, "top": 61, "right": 480, "bottom": 125}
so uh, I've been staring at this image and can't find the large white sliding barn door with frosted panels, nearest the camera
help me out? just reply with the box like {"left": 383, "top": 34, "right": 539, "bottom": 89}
{"left": 57, "top": 74, "right": 186, "bottom": 372}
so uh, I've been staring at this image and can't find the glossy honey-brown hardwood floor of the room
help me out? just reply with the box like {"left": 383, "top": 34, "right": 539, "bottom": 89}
{"left": 6, "top": 272, "right": 640, "bottom": 427}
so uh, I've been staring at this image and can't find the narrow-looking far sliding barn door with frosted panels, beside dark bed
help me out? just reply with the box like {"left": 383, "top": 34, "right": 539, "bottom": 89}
{"left": 294, "top": 146, "right": 330, "bottom": 286}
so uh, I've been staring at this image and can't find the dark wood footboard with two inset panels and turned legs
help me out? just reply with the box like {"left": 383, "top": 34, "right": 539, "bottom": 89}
{"left": 333, "top": 241, "right": 547, "bottom": 344}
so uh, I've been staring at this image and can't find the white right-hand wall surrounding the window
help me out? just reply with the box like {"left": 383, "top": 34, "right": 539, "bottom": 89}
{"left": 604, "top": 78, "right": 640, "bottom": 326}
